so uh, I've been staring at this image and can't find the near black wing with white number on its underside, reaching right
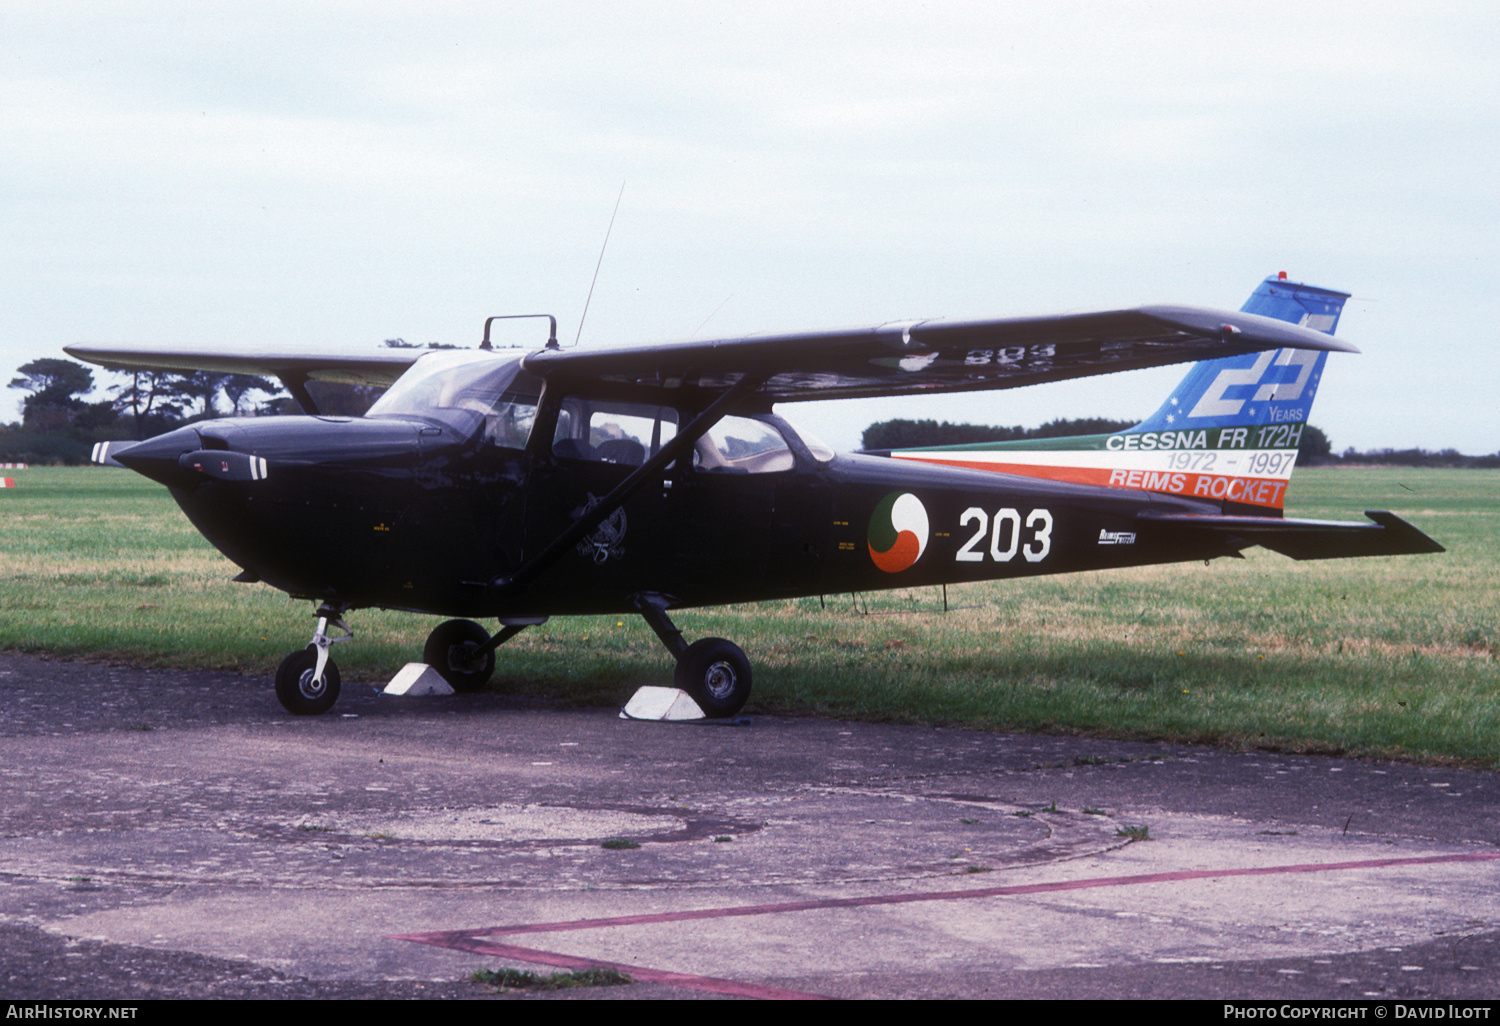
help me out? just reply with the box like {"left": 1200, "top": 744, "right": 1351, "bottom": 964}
{"left": 525, "top": 306, "right": 1359, "bottom": 402}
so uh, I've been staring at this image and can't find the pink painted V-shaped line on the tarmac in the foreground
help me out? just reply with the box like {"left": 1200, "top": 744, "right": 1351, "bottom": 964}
{"left": 390, "top": 852, "right": 1500, "bottom": 998}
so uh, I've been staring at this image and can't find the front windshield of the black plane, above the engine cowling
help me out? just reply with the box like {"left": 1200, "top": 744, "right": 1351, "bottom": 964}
{"left": 366, "top": 350, "right": 542, "bottom": 449}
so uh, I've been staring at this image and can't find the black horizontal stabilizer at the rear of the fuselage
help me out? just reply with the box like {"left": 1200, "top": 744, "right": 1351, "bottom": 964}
{"left": 1140, "top": 510, "right": 1445, "bottom": 560}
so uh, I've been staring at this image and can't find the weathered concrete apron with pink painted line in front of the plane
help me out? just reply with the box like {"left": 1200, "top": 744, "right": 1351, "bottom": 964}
{"left": 0, "top": 654, "right": 1500, "bottom": 996}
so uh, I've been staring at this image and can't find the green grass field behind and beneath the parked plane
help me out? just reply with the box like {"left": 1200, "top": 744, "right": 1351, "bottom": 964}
{"left": 0, "top": 468, "right": 1500, "bottom": 768}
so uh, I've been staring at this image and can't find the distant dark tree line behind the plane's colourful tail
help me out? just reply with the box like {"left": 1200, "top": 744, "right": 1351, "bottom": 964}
{"left": 861, "top": 417, "right": 1500, "bottom": 468}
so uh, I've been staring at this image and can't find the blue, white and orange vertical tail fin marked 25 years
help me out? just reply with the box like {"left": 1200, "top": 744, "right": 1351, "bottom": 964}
{"left": 891, "top": 273, "right": 1349, "bottom": 516}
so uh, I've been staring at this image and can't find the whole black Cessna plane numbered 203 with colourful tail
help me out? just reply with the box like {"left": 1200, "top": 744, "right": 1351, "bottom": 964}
{"left": 68, "top": 276, "right": 1442, "bottom": 716}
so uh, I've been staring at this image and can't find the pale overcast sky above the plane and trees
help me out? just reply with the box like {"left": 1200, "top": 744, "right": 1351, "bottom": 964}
{"left": 0, "top": 0, "right": 1500, "bottom": 453}
